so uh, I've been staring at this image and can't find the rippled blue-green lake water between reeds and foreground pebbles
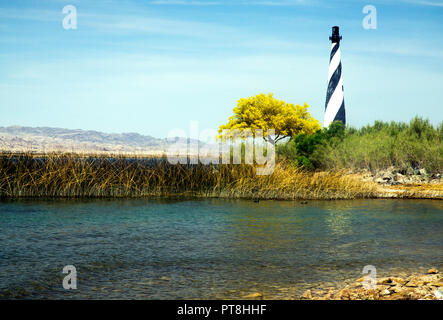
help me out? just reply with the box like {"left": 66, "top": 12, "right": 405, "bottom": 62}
{"left": 0, "top": 199, "right": 443, "bottom": 299}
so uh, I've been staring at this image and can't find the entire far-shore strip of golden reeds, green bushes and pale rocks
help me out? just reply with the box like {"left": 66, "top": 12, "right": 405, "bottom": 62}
{"left": 0, "top": 117, "right": 443, "bottom": 200}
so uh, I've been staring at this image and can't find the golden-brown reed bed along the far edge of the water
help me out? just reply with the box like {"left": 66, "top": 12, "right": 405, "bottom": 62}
{"left": 0, "top": 153, "right": 377, "bottom": 200}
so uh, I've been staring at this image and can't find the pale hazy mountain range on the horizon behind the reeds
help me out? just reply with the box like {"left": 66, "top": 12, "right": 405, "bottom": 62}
{"left": 0, "top": 126, "right": 201, "bottom": 154}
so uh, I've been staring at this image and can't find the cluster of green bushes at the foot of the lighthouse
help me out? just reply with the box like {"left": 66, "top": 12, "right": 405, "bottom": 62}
{"left": 277, "top": 117, "right": 443, "bottom": 173}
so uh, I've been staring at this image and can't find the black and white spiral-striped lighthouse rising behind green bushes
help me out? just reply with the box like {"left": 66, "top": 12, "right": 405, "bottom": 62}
{"left": 323, "top": 26, "right": 346, "bottom": 127}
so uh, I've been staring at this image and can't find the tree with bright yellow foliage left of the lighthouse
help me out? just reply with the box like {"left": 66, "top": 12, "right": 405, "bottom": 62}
{"left": 218, "top": 93, "right": 321, "bottom": 143}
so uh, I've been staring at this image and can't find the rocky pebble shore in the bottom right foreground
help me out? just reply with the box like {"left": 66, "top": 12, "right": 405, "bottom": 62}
{"left": 300, "top": 269, "right": 443, "bottom": 300}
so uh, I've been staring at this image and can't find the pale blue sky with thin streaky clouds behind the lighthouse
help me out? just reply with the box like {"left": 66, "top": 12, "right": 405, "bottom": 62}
{"left": 0, "top": 0, "right": 443, "bottom": 137}
